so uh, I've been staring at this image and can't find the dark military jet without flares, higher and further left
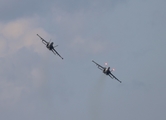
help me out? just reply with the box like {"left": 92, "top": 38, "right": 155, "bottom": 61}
{"left": 37, "top": 34, "right": 63, "bottom": 59}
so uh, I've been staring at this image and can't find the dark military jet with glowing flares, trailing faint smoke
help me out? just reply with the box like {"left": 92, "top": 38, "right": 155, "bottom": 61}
{"left": 92, "top": 60, "right": 121, "bottom": 83}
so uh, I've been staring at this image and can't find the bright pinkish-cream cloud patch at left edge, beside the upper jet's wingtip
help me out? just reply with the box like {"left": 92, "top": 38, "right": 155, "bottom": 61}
{"left": 0, "top": 18, "right": 47, "bottom": 56}
